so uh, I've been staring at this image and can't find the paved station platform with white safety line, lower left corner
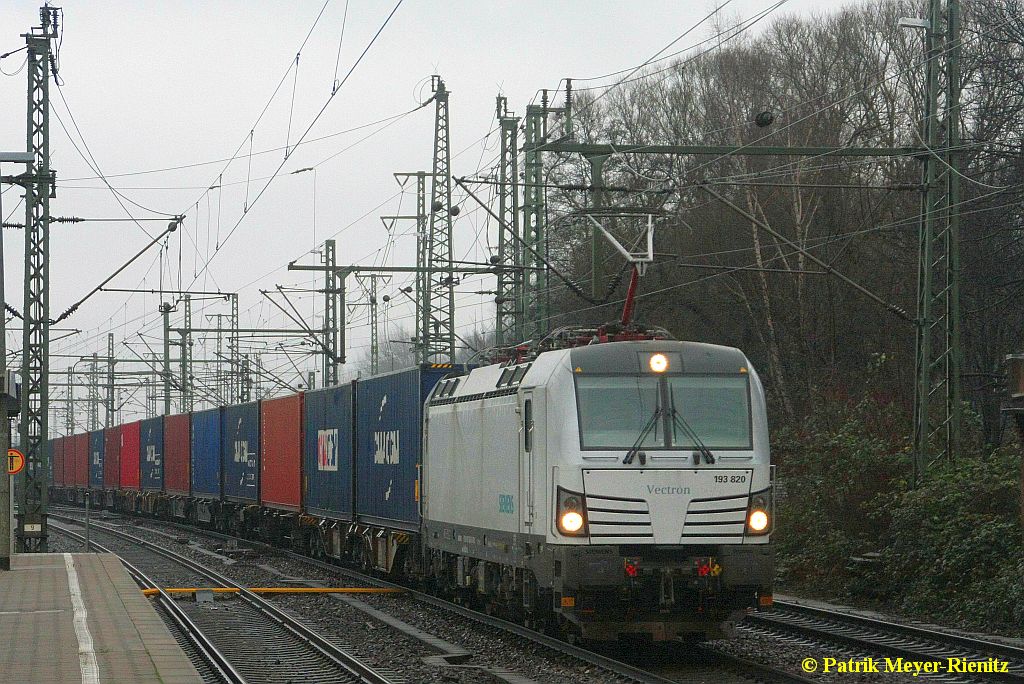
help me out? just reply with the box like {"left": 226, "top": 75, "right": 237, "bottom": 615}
{"left": 0, "top": 553, "right": 203, "bottom": 684}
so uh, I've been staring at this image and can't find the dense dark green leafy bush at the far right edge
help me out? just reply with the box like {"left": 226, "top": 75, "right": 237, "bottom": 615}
{"left": 874, "top": 450, "right": 1024, "bottom": 631}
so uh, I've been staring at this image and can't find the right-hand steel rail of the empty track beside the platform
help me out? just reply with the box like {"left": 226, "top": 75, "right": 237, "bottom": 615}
{"left": 50, "top": 513, "right": 393, "bottom": 684}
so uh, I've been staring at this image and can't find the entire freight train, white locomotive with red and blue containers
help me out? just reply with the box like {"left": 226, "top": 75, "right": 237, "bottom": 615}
{"left": 51, "top": 341, "right": 774, "bottom": 640}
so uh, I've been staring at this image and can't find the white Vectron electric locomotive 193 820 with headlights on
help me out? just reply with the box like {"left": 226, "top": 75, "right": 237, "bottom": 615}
{"left": 420, "top": 340, "right": 773, "bottom": 640}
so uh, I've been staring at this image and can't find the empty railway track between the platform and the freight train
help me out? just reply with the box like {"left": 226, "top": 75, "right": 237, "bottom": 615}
{"left": 50, "top": 515, "right": 404, "bottom": 684}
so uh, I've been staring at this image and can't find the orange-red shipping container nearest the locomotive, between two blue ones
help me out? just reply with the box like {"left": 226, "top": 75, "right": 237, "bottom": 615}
{"left": 259, "top": 394, "right": 302, "bottom": 511}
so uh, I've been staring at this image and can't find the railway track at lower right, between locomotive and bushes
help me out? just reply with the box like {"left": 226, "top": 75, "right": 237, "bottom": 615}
{"left": 743, "top": 601, "right": 1024, "bottom": 684}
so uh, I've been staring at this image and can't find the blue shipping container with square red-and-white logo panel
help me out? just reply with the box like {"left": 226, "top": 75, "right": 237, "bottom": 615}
{"left": 302, "top": 384, "right": 352, "bottom": 520}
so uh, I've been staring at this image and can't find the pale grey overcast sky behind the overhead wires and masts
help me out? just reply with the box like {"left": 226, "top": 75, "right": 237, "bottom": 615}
{"left": 0, "top": 0, "right": 845, "bottom": 426}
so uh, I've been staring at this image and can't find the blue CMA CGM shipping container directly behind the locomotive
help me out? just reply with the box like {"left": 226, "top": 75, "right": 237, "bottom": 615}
{"left": 355, "top": 368, "right": 451, "bottom": 529}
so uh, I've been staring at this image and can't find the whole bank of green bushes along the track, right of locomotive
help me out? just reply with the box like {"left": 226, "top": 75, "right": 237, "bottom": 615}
{"left": 774, "top": 399, "right": 1024, "bottom": 633}
